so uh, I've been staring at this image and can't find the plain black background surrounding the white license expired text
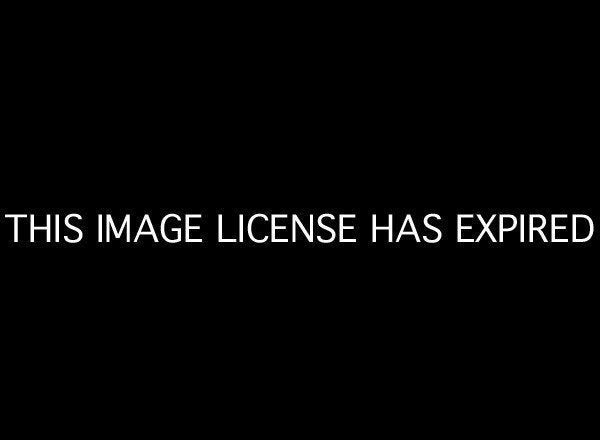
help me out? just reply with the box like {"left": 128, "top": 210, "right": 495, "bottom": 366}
{"left": 1, "top": 5, "right": 598, "bottom": 433}
